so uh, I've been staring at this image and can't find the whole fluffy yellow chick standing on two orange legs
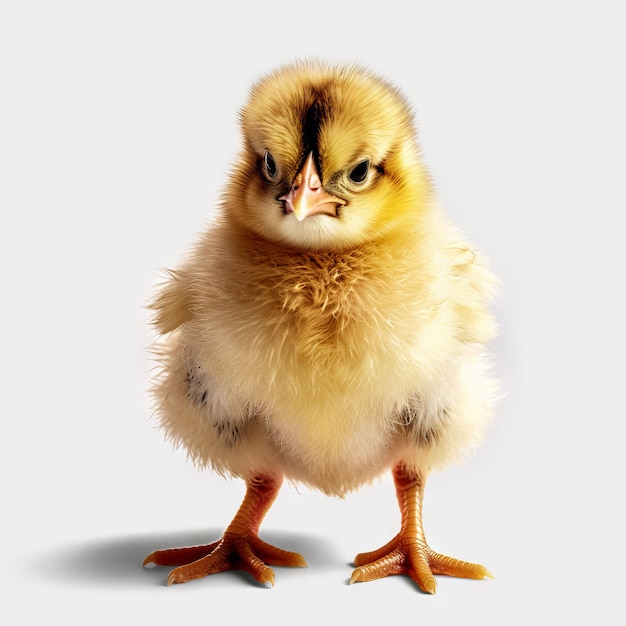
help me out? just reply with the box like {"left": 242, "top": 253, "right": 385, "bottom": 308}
{"left": 144, "top": 62, "right": 495, "bottom": 593}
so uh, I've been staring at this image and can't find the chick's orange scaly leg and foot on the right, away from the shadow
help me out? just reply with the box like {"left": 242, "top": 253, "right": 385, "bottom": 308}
{"left": 350, "top": 464, "right": 493, "bottom": 593}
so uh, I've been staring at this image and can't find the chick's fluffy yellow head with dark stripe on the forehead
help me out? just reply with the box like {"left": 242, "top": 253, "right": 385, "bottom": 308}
{"left": 227, "top": 62, "right": 429, "bottom": 249}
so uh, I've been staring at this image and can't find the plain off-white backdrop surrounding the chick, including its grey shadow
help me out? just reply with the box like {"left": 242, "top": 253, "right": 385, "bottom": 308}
{"left": 0, "top": 0, "right": 624, "bottom": 625}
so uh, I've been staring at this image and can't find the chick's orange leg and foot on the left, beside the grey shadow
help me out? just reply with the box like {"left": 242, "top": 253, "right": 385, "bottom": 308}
{"left": 143, "top": 476, "right": 306, "bottom": 587}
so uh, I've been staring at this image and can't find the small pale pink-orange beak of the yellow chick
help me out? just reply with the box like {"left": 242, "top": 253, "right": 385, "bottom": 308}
{"left": 278, "top": 152, "right": 346, "bottom": 222}
